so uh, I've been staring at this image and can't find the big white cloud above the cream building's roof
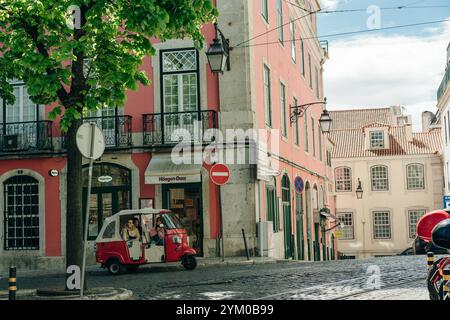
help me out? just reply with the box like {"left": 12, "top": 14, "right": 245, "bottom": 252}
{"left": 324, "top": 19, "right": 450, "bottom": 130}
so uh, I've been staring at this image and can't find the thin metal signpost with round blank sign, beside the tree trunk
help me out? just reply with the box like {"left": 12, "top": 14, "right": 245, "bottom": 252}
{"left": 76, "top": 123, "right": 106, "bottom": 298}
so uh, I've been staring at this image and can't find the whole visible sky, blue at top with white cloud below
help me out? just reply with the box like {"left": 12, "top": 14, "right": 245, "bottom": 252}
{"left": 319, "top": 0, "right": 450, "bottom": 130}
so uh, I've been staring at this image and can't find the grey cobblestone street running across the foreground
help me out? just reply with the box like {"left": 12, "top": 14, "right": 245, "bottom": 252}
{"left": 0, "top": 256, "right": 428, "bottom": 300}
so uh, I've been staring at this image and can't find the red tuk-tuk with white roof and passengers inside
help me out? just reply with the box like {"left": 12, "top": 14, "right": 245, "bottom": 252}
{"left": 95, "top": 209, "right": 197, "bottom": 275}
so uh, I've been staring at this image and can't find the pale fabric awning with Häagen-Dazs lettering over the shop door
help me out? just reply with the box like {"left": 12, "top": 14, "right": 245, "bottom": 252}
{"left": 145, "top": 153, "right": 202, "bottom": 184}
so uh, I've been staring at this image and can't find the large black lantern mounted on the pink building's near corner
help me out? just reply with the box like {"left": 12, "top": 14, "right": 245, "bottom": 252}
{"left": 206, "top": 23, "right": 233, "bottom": 73}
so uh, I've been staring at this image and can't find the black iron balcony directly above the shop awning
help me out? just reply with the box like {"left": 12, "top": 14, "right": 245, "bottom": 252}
{"left": 143, "top": 110, "right": 217, "bottom": 146}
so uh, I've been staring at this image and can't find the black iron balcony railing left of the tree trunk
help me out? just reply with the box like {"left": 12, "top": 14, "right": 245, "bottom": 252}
{"left": 0, "top": 121, "right": 53, "bottom": 154}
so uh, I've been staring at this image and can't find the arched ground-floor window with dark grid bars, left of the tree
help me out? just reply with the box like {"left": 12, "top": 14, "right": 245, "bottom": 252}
{"left": 4, "top": 176, "right": 39, "bottom": 250}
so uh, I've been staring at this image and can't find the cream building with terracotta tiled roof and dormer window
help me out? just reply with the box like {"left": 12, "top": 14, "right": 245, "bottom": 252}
{"left": 330, "top": 107, "right": 443, "bottom": 258}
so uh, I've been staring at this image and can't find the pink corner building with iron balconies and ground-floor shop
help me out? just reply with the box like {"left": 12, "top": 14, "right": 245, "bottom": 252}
{"left": 0, "top": 0, "right": 336, "bottom": 268}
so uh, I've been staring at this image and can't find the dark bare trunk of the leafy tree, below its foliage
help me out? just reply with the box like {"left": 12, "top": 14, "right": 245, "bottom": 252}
{"left": 66, "top": 120, "right": 84, "bottom": 289}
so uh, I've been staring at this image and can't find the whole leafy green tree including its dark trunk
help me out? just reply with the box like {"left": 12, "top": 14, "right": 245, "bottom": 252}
{"left": 0, "top": 0, "right": 217, "bottom": 290}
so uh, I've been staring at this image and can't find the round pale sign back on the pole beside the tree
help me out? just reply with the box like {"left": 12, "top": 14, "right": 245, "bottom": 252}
{"left": 76, "top": 123, "right": 106, "bottom": 160}
